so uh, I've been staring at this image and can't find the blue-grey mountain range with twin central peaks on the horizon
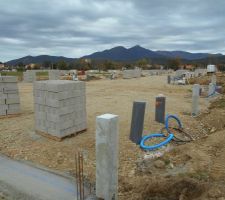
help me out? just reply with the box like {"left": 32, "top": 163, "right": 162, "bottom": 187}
{"left": 3, "top": 45, "right": 225, "bottom": 66}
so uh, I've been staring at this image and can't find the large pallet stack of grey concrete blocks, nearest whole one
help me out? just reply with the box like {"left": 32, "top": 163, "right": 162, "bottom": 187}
{"left": 34, "top": 80, "right": 87, "bottom": 138}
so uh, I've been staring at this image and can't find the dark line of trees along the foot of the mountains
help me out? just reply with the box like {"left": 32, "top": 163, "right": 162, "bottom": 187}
{"left": 9, "top": 57, "right": 225, "bottom": 71}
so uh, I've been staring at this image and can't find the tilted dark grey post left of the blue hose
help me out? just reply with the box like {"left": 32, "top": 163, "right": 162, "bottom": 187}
{"left": 130, "top": 101, "right": 146, "bottom": 144}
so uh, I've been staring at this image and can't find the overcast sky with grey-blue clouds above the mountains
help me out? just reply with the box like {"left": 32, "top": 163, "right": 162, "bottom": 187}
{"left": 0, "top": 0, "right": 225, "bottom": 61}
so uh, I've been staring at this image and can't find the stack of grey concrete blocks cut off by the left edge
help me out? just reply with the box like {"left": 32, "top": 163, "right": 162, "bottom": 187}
{"left": 0, "top": 76, "right": 20, "bottom": 115}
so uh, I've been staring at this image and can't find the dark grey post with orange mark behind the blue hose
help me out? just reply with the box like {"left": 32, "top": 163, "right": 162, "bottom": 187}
{"left": 155, "top": 94, "right": 166, "bottom": 123}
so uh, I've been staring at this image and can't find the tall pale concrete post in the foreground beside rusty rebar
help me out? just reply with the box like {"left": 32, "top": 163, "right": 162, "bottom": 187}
{"left": 96, "top": 114, "right": 119, "bottom": 200}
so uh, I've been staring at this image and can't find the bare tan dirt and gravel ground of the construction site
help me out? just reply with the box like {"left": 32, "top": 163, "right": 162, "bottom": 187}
{"left": 0, "top": 76, "right": 225, "bottom": 200}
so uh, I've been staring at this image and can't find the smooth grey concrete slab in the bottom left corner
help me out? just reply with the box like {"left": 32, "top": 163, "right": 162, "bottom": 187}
{"left": 0, "top": 156, "right": 87, "bottom": 200}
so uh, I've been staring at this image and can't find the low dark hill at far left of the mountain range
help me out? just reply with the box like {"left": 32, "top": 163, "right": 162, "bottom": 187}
{"left": 6, "top": 55, "right": 75, "bottom": 65}
